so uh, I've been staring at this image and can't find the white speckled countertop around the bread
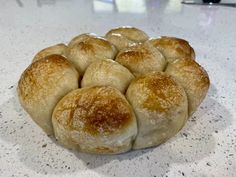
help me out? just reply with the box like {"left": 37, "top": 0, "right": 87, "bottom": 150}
{"left": 0, "top": 0, "right": 236, "bottom": 177}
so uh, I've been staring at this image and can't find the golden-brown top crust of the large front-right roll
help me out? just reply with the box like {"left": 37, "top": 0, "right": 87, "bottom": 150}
{"left": 129, "top": 72, "right": 185, "bottom": 112}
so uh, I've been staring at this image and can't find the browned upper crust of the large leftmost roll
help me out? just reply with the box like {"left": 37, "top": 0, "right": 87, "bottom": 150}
{"left": 18, "top": 55, "right": 77, "bottom": 101}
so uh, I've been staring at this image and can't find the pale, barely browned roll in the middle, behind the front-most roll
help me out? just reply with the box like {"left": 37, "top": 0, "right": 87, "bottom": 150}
{"left": 81, "top": 59, "right": 134, "bottom": 93}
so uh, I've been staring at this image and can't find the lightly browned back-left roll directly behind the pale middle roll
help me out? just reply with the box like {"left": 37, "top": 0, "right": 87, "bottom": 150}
{"left": 67, "top": 34, "right": 117, "bottom": 75}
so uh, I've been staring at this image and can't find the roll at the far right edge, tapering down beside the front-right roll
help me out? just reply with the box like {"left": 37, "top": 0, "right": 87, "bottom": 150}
{"left": 166, "top": 59, "right": 210, "bottom": 116}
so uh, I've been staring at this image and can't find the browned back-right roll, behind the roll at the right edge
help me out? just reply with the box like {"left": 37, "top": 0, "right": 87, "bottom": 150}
{"left": 147, "top": 36, "right": 195, "bottom": 62}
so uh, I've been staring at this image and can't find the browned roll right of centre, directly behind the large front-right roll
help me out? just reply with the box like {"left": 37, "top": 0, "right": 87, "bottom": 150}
{"left": 116, "top": 44, "right": 166, "bottom": 76}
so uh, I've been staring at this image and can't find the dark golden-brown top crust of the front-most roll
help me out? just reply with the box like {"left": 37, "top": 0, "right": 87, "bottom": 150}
{"left": 54, "top": 87, "right": 133, "bottom": 135}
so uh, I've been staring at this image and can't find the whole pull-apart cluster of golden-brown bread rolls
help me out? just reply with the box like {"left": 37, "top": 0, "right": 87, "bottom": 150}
{"left": 17, "top": 27, "right": 210, "bottom": 154}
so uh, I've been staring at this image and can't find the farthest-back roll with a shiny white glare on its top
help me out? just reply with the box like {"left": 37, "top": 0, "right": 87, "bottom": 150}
{"left": 105, "top": 26, "right": 149, "bottom": 50}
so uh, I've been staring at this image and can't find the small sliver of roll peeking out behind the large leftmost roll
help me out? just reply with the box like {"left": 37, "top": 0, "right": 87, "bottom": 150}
{"left": 32, "top": 43, "right": 67, "bottom": 62}
